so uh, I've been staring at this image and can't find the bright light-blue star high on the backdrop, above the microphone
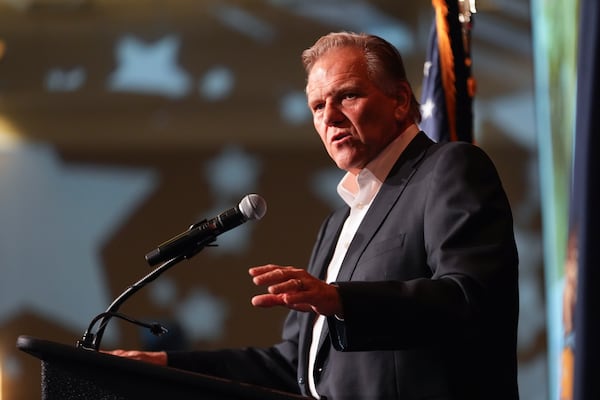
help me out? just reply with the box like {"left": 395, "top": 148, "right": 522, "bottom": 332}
{"left": 108, "top": 34, "right": 192, "bottom": 98}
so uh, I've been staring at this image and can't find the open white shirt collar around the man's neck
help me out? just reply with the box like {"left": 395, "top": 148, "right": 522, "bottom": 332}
{"left": 337, "top": 125, "right": 419, "bottom": 208}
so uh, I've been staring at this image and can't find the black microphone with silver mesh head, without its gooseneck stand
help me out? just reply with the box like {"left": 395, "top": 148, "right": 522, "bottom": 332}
{"left": 145, "top": 194, "right": 267, "bottom": 266}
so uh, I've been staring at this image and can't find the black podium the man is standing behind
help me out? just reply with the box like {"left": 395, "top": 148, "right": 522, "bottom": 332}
{"left": 17, "top": 335, "right": 308, "bottom": 400}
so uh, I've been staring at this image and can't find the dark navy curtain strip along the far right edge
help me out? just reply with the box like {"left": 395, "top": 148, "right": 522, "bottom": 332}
{"left": 572, "top": 0, "right": 600, "bottom": 400}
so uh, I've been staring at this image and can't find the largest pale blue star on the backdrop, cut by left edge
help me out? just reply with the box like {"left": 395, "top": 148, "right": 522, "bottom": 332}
{"left": 0, "top": 144, "right": 157, "bottom": 340}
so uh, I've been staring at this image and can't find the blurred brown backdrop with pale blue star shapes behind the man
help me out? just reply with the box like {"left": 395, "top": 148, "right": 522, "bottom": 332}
{"left": 0, "top": 0, "right": 547, "bottom": 400}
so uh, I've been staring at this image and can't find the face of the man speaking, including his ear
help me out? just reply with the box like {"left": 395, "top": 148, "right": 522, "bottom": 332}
{"left": 306, "top": 47, "right": 408, "bottom": 174}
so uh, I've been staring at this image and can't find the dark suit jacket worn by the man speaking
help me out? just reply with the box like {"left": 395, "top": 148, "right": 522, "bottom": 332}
{"left": 169, "top": 133, "right": 518, "bottom": 400}
